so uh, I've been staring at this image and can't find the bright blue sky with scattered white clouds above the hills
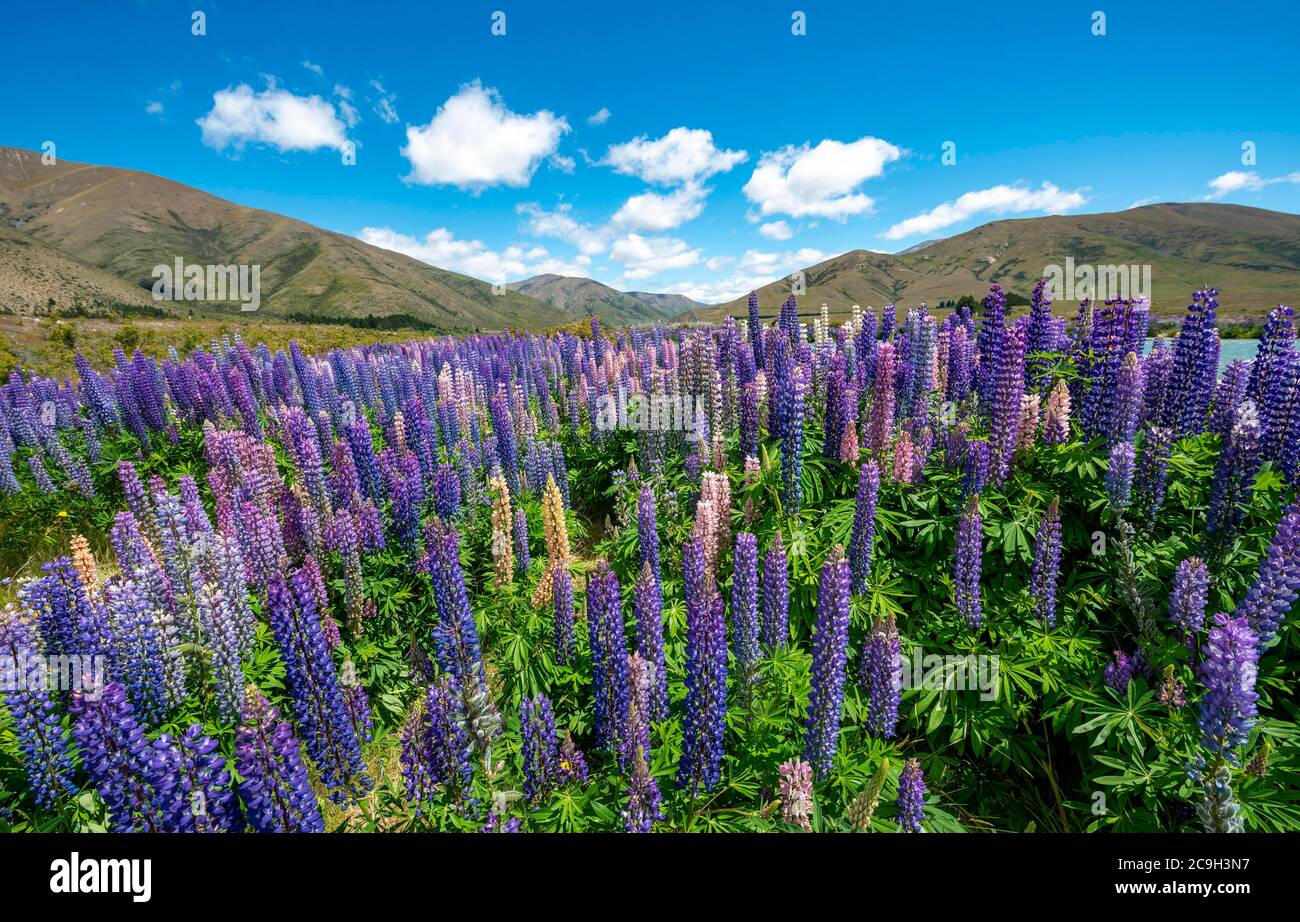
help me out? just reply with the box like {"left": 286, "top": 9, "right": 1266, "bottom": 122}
{"left": 0, "top": 0, "right": 1300, "bottom": 300}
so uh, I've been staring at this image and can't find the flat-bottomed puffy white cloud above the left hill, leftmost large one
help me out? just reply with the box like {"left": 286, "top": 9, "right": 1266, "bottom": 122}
{"left": 196, "top": 79, "right": 347, "bottom": 152}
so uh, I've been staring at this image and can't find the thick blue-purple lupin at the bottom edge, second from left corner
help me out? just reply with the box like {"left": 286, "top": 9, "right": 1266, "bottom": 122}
{"left": 69, "top": 681, "right": 165, "bottom": 832}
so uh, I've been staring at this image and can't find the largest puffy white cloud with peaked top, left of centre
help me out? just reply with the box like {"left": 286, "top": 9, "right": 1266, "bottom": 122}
{"left": 402, "top": 81, "right": 569, "bottom": 191}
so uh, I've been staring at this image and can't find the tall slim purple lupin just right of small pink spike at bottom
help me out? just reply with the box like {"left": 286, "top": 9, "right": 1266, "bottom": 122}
{"left": 803, "top": 545, "right": 853, "bottom": 778}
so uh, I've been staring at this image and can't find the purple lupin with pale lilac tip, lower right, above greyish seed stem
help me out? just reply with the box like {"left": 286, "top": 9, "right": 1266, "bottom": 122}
{"left": 1196, "top": 614, "right": 1260, "bottom": 765}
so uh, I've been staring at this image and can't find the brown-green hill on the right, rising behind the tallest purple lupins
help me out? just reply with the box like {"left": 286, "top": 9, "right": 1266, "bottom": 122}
{"left": 692, "top": 203, "right": 1300, "bottom": 320}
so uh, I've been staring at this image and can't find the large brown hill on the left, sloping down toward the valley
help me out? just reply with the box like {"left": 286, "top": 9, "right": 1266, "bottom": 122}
{"left": 0, "top": 148, "right": 569, "bottom": 330}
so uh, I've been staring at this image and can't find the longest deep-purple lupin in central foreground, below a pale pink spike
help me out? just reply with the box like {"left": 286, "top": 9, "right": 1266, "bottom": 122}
{"left": 677, "top": 538, "right": 727, "bottom": 793}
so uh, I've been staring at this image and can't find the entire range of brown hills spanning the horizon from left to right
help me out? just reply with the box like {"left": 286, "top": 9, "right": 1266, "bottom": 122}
{"left": 0, "top": 147, "right": 1300, "bottom": 332}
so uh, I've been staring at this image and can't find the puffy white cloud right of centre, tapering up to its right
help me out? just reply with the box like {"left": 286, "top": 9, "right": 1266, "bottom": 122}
{"left": 745, "top": 137, "right": 902, "bottom": 221}
